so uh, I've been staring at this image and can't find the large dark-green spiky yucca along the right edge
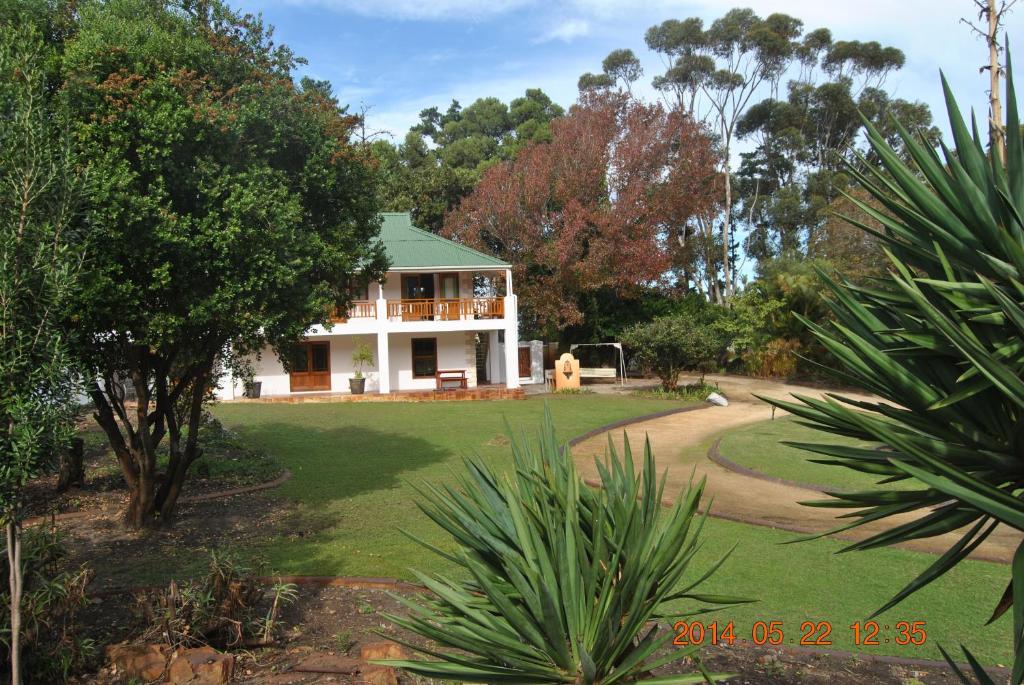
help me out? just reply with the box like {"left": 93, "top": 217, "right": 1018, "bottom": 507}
{"left": 767, "top": 53, "right": 1024, "bottom": 683}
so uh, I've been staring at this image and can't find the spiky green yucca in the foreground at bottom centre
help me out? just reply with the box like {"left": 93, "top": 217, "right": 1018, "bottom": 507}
{"left": 388, "top": 415, "right": 741, "bottom": 685}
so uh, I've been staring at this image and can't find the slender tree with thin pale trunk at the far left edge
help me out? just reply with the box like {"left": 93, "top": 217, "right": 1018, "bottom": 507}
{"left": 0, "top": 18, "right": 81, "bottom": 683}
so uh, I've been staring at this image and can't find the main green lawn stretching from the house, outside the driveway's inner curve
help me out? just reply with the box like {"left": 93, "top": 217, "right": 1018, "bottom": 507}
{"left": 215, "top": 394, "right": 1011, "bottom": 663}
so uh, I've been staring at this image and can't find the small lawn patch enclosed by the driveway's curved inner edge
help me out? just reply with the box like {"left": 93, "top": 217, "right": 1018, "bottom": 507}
{"left": 719, "top": 416, "right": 892, "bottom": 491}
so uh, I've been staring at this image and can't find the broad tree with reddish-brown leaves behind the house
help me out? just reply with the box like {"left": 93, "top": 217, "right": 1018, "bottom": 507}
{"left": 444, "top": 93, "right": 718, "bottom": 332}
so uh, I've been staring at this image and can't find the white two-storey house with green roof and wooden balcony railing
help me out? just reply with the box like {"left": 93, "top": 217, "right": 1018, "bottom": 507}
{"left": 218, "top": 213, "right": 520, "bottom": 399}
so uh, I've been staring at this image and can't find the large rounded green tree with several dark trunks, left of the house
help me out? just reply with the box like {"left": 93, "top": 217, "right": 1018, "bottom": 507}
{"left": 62, "top": 0, "right": 385, "bottom": 526}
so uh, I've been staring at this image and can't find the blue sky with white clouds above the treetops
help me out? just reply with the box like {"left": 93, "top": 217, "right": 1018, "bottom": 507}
{"left": 232, "top": 0, "right": 1024, "bottom": 139}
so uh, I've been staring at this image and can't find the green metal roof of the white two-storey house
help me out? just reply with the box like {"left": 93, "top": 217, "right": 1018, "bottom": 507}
{"left": 380, "top": 212, "right": 509, "bottom": 269}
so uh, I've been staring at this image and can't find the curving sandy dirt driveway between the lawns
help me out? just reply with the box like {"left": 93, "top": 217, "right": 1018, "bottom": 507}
{"left": 572, "top": 376, "right": 1022, "bottom": 562}
